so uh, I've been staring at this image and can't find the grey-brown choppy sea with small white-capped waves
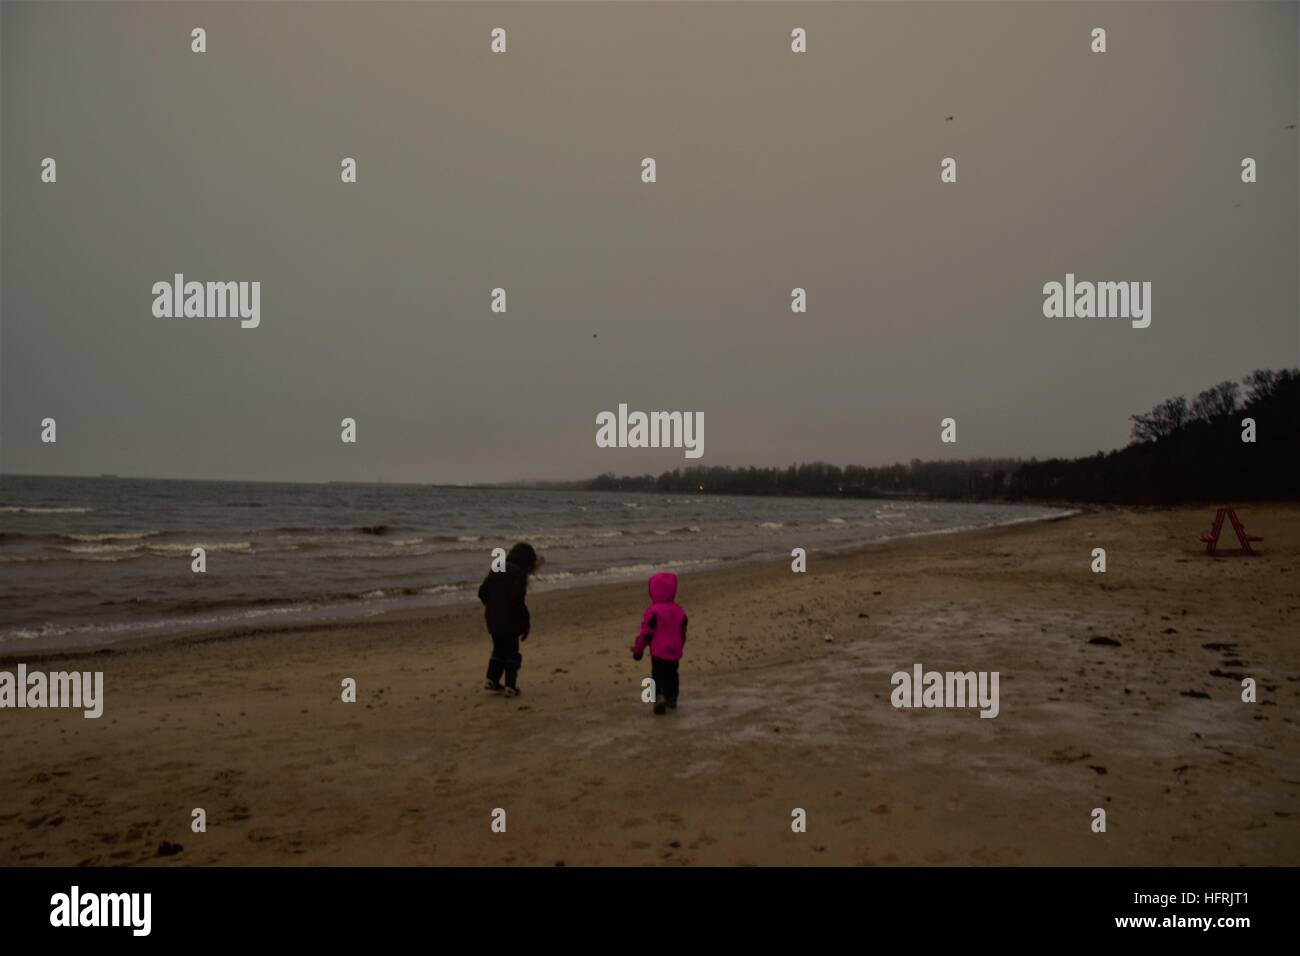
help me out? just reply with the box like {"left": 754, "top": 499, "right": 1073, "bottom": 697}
{"left": 0, "top": 475, "right": 1061, "bottom": 653}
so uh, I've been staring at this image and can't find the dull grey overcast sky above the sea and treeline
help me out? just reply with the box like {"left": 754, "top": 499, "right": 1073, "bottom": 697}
{"left": 0, "top": 3, "right": 1300, "bottom": 483}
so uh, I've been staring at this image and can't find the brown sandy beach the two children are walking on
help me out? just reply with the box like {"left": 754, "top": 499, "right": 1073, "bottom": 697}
{"left": 0, "top": 506, "right": 1300, "bottom": 866}
